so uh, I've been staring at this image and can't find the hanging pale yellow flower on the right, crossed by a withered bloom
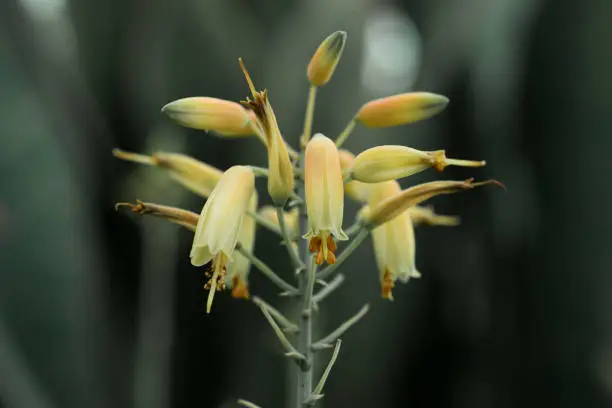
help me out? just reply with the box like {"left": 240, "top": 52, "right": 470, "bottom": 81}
{"left": 369, "top": 181, "right": 421, "bottom": 300}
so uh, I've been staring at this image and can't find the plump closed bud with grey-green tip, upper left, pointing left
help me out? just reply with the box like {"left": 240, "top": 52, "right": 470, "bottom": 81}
{"left": 162, "top": 96, "right": 252, "bottom": 135}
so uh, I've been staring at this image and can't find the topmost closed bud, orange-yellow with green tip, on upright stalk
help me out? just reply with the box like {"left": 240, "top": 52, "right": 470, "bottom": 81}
{"left": 307, "top": 31, "right": 346, "bottom": 86}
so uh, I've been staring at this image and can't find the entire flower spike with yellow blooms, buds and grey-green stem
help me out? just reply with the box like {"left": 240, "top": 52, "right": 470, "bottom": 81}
{"left": 113, "top": 31, "right": 500, "bottom": 408}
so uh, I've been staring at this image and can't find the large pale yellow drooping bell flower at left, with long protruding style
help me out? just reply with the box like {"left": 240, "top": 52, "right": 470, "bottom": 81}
{"left": 190, "top": 166, "right": 255, "bottom": 313}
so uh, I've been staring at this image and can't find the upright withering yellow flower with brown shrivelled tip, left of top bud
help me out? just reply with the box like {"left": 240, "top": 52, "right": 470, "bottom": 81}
{"left": 239, "top": 59, "right": 293, "bottom": 206}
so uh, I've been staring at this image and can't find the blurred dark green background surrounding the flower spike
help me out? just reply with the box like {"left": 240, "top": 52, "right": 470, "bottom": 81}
{"left": 0, "top": 0, "right": 612, "bottom": 408}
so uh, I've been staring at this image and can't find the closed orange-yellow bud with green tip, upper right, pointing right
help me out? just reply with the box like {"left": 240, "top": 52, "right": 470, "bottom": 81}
{"left": 355, "top": 92, "right": 448, "bottom": 128}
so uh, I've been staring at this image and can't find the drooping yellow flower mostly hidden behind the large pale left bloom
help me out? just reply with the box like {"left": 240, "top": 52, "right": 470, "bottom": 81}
{"left": 226, "top": 192, "right": 257, "bottom": 299}
